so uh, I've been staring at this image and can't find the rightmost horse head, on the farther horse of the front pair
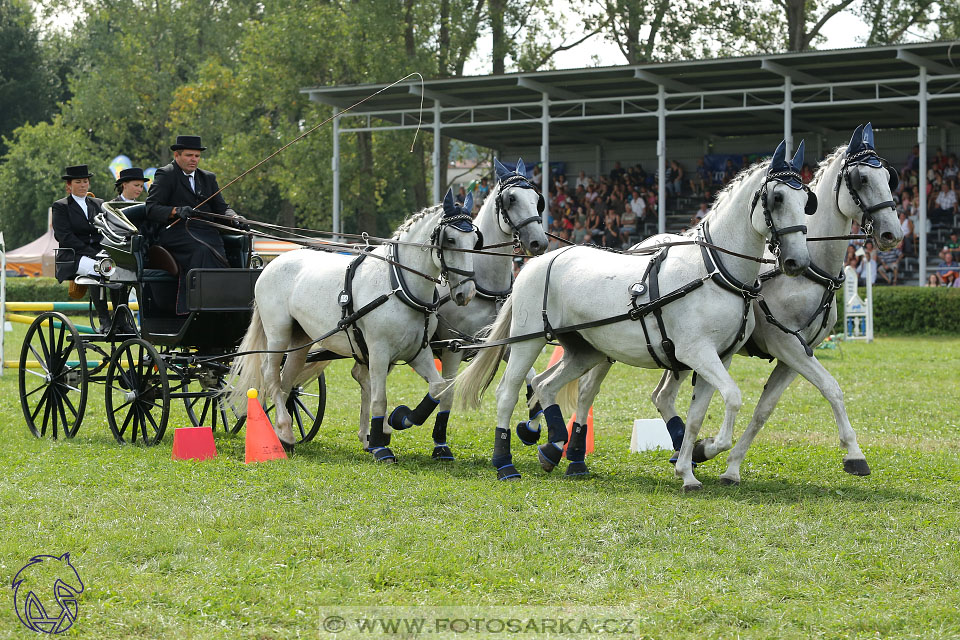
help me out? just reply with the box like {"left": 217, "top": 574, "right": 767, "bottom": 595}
{"left": 835, "top": 122, "right": 903, "bottom": 249}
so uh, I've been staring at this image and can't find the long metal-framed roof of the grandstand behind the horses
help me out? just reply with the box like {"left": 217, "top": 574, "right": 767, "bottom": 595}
{"left": 302, "top": 41, "right": 960, "bottom": 149}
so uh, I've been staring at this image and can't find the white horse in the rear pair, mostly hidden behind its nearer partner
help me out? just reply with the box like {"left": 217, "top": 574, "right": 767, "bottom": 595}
{"left": 433, "top": 158, "right": 547, "bottom": 460}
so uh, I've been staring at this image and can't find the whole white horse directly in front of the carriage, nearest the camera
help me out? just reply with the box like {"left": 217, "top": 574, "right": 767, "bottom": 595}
{"left": 231, "top": 191, "right": 479, "bottom": 462}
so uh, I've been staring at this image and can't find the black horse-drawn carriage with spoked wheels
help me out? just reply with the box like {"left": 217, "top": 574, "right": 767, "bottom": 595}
{"left": 19, "top": 203, "right": 326, "bottom": 445}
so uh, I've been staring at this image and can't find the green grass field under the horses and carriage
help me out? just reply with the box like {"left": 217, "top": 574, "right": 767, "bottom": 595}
{"left": 0, "top": 316, "right": 960, "bottom": 639}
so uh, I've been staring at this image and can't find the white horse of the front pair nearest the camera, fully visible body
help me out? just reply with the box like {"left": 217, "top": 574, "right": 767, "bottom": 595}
{"left": 457, "top": 143, "right": 816, "bottom": 490}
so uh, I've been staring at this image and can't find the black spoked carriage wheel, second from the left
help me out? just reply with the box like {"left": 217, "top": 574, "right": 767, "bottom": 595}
{"left": 104, "top": 338, "right": 170, "bottom": 445}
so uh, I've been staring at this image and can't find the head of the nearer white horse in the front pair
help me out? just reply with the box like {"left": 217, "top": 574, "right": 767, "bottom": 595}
{"left": 752, "top": 142, "right": 817, "bottom": 276}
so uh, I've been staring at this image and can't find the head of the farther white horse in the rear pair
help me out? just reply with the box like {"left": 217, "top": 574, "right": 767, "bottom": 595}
{"left": 493, "top": 158, "right": 547, "bottom": 256}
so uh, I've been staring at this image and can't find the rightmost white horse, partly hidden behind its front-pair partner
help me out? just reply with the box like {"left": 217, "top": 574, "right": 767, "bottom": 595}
{"left": 577, "top": 122, "right": 903, "bottom": 485}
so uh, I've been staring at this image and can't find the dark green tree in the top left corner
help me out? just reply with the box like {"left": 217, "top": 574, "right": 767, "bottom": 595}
{"left": 0, "top": 0, "right": 57, "bottom": 155}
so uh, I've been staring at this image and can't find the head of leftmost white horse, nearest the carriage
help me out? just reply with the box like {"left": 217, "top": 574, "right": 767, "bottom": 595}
{"left": 433, "top": 189, "right": 483, "bottom": 307}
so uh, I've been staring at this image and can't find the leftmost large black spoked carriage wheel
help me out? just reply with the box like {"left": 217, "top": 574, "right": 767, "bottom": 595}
{"left": 19, "top": 311, "right": 87, "bottom": 440}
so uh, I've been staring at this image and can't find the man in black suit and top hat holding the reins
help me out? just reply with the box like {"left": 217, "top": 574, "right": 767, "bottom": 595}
{"left": 146, "top": 136, "right": 246, "bottom": 315}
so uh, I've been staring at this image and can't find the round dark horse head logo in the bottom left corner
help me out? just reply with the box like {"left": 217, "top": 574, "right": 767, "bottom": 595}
{"left": 11, "top": 553, "right": 83, "bottom": 633}
